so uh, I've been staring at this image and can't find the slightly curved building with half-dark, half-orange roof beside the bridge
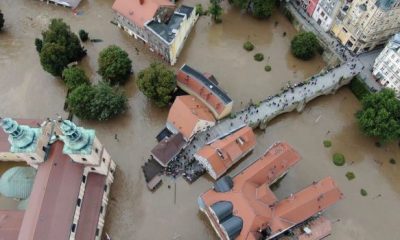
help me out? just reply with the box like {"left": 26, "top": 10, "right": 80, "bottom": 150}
{"left": 176, "top": 64, "right": 233, "bottom": 120}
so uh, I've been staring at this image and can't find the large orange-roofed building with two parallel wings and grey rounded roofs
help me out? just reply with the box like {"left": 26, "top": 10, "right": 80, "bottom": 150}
{"left": 198, "top": 143, "right": 342, "bottom": 240}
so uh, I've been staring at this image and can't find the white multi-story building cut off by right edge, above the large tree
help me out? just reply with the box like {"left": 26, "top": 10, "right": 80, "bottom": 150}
{"left": 373, "top": 33, "right": 400, "bottom": 96}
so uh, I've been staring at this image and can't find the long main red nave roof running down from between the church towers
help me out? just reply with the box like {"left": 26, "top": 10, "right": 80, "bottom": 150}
{"left": 18, "top": 141, "right": 84, "bottom": 240}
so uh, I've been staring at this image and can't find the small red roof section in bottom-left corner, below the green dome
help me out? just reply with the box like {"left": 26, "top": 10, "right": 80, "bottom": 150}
{"left": 0, "top": 210, "right": 25, "bottom": 240}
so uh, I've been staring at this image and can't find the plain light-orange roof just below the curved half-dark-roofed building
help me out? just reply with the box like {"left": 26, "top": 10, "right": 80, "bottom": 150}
{"left": 167, "top": 95, "right": 215, "bottom": 139}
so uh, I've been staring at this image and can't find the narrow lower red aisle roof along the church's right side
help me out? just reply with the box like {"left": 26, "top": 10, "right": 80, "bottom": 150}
{"left": 75, "top": 173, "right": 106, "bottom": 240}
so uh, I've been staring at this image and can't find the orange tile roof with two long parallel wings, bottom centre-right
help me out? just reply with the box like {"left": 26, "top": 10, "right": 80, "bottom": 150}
{"left": 200, "top": 143, "right": 342, "bottom": 240}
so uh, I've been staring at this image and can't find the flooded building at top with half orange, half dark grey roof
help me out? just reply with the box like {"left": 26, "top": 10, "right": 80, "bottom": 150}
{"left": 112, "top": 0, "right": 199, "bottom": 65}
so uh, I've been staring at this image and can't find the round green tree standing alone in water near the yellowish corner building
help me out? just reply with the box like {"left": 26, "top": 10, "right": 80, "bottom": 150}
{"left": 291, "top": 32, "right": 320, "bottom": 60}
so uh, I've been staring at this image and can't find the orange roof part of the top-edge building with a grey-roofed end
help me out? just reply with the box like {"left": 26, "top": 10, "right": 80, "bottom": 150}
{"left": 112, "top": 0, "right": 175, "bottom": 27}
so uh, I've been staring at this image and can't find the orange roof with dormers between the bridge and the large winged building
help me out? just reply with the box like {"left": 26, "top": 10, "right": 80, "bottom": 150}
{"left": 196, "top": 126, "right": 256, "bottom": 179}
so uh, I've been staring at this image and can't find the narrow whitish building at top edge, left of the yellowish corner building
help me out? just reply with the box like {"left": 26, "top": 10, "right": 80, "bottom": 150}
{"left": 312, "top": 0, "right": 341, "bottom": 32}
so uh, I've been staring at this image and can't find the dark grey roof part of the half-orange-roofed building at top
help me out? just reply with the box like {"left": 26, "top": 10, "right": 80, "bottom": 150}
{"left": 146, "top": 13, "right": 184, "bottom": 43}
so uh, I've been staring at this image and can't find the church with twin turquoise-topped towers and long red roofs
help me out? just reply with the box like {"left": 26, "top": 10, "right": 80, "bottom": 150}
{"left": 0, "top": 118, "right": 116, "bottom": 240}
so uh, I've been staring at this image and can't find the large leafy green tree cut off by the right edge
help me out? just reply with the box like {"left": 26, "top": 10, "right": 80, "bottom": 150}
{"left": 356, "top": 89, "right": 400, "bottom": 143}
